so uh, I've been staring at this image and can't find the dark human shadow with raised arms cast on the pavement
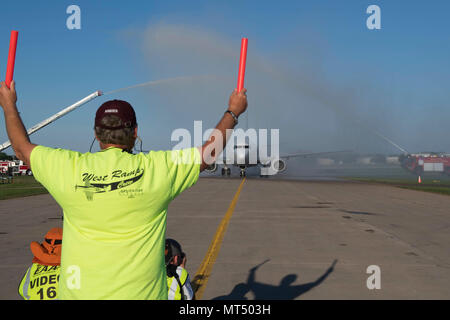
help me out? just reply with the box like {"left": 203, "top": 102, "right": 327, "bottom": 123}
{"left": 213, "top": 260, "right": 337, "bottom": 300}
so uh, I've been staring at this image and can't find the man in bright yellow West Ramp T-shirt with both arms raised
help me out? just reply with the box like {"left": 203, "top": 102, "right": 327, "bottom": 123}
{"left": 0, "top": 81, "right": 247, "bottom": 299}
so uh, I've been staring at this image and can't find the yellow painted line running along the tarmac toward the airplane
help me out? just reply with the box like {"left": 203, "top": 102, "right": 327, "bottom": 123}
{"left": 192, "top": 178, "right": 245, "bottom": 300}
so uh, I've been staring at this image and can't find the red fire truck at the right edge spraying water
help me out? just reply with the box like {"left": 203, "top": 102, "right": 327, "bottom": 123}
{"left": 399, "top": 153, "right": 450, "bottom": 175}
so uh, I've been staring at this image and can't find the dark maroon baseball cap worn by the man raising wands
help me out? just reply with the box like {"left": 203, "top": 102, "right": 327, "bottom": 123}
{"left": 95, "top": 100, "right": 137, "bottom": 130}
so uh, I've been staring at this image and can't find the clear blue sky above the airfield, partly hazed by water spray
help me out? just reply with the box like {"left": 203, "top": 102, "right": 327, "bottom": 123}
{"left": 0, "top": 0, "right": 450, "bottom": 153}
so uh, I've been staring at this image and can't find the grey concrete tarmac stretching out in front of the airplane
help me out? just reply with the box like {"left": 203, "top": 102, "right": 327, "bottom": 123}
{"left": 0, "top": 178, "right": 450, "bottom": 300}
